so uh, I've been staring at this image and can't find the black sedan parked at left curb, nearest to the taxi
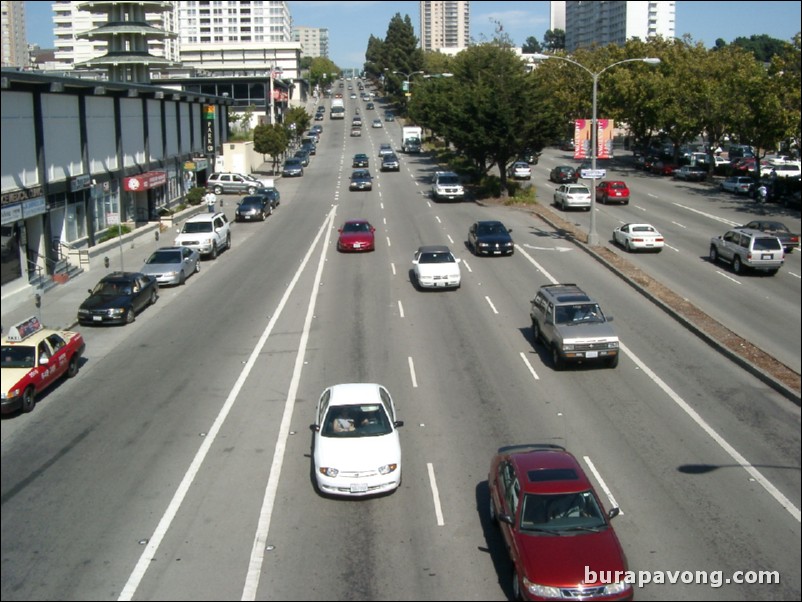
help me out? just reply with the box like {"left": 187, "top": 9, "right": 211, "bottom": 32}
{"left": 78, "top": 272, "right": 159, "bottom": 326}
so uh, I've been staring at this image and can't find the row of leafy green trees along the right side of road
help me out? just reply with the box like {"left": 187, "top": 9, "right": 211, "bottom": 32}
{"left": 365, "top": 14, "right": 802, "bottom": 190}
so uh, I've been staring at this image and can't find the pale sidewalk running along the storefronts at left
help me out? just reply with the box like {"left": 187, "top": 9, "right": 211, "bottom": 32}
{"left": 0, "top": 204, "right": 209, "bottom": 335}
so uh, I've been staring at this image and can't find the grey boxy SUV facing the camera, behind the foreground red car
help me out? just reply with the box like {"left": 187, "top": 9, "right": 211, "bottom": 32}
{"left": 529, "top": 284, "right": 619, "bottom": 370}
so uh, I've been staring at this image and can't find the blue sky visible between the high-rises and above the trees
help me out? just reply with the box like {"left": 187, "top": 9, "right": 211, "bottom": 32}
{"left": 25, "top": 0, "right": 802, "bottom": 68}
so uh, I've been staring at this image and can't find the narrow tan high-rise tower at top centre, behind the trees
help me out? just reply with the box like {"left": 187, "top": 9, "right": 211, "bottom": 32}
{"left": 420, "top": 1, "right": 471, "bottom": 53}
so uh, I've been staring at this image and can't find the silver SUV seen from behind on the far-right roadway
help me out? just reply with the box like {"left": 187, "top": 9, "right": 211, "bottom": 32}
{"left": 709, "top": 228, "right": 785, "bottom": 276}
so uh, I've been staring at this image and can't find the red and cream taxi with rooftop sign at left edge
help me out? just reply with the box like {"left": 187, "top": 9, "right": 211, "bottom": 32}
{"left": 0, "top": 316, "right": 86, "bottom": 414}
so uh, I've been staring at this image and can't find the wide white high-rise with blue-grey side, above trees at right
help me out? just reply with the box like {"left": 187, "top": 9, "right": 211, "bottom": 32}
{"left": 550, "top": 0, "right": 676, "bottom": 52}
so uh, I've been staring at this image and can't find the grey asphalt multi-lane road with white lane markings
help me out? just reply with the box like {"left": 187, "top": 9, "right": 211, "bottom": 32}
{"left": 1, "top": 90, "right": 802, "bottom": 600}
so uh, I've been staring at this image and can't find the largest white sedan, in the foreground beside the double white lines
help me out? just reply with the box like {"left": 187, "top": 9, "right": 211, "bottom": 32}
{"left": 312, "top": 383, "right": 404, "bottom": 497}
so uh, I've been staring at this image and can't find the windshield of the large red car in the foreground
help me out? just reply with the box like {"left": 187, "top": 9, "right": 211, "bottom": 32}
{"left": 521, "top": 491, "right": 607, "bottom": 531}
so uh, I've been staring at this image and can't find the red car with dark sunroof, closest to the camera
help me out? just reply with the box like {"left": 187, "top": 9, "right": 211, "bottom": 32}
{"left": 487, "top": 444, "right": 633, "bottom": 600}
